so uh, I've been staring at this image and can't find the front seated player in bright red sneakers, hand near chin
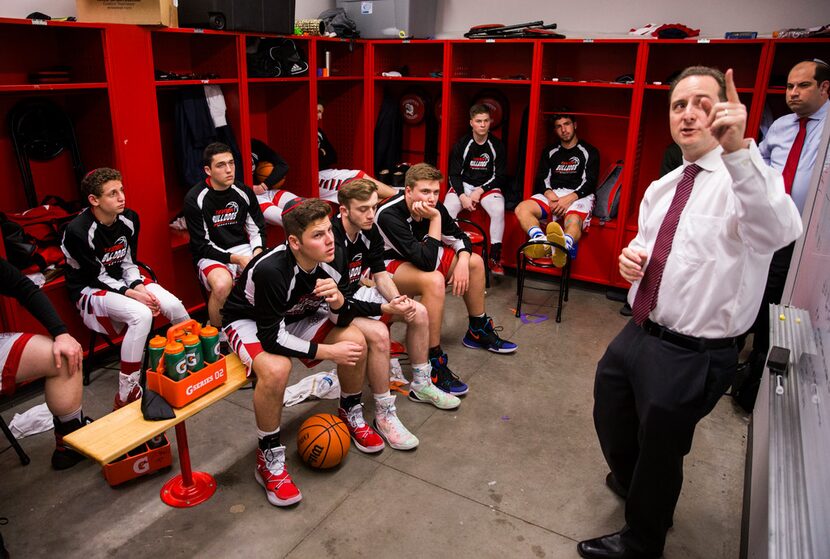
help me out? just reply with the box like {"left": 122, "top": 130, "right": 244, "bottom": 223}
{"left": 222, "top": 200, "right": 417, "bottom": 506}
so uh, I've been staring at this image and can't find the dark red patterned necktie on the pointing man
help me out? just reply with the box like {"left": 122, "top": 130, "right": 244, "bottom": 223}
{"left": 632, "top": 163, "right": 700, "bottom": 324}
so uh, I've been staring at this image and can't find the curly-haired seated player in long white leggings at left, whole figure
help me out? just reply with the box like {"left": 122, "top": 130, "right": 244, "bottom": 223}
{"left": 61, "top": 167, "right": 190, "bottom": 409}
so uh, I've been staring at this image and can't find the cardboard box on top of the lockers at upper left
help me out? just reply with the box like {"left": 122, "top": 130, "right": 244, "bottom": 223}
{"left": 75, "top": 0, "right": 179, "bottom": 27}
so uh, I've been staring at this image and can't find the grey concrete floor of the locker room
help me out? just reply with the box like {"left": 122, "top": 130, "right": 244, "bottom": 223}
{"left": 0, "top": 278, "right": 747, "bottom": 559}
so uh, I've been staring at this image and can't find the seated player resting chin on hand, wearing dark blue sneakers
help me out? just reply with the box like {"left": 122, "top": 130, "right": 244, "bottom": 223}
{"left": 376, "top": 163, "right": 517, "bottom": 395}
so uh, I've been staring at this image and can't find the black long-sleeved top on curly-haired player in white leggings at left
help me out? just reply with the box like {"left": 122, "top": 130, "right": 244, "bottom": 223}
{"left": 61, "top": 208, "right": 142, "bottom": 302}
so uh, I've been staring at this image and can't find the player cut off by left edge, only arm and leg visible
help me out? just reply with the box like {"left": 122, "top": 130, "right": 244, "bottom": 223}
{"left": 0, "top": 258, "right": 88, "bottom": 470}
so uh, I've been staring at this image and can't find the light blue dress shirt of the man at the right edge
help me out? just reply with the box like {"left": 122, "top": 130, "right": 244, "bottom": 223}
{"left": 758, "top": 101, "right": 830, "bottom": 212}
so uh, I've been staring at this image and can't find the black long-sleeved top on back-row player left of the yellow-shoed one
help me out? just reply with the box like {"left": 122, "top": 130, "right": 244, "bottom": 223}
{"left": 449, "top": 132, "right": 507, "bottom": 194}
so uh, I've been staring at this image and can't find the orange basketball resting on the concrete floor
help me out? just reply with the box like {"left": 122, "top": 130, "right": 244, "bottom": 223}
{"left": 297, "top": 413, "right": 350, "bottom": 469}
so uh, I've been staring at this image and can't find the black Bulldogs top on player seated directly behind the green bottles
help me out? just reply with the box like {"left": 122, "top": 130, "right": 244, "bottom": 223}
{"left": 184, "top": 178, "right": 265, "bottom": 264}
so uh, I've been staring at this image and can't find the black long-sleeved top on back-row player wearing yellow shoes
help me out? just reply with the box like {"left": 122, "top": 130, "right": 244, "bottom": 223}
{"left": 535, "top": 140, "right": 599, "bottom": 198}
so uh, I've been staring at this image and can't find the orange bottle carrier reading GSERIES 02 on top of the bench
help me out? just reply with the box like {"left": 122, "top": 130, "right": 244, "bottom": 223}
{"left": 147, "top": 320, "right": 228, "bottom": 408}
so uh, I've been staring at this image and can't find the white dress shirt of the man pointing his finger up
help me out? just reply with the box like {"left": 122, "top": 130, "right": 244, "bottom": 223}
{"left": 628, "top": 141, "right": 802, "bottom": 338}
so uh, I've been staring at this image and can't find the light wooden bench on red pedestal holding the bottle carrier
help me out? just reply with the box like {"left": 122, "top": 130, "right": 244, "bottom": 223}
{"left": 64, "top": 355, "right": 249, "bottom": 507}
